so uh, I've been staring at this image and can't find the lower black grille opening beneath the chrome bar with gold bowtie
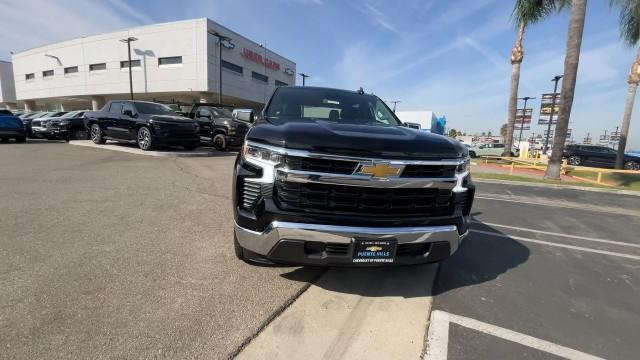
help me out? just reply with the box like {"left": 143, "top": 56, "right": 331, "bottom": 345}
{"left": 275, "top": 181, "right": 453, "bottom": 216}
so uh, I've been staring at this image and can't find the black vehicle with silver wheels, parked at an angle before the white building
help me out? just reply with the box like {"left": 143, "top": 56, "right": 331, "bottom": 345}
{"left": 84, "top": 101, "right": 200, "bottom": 150}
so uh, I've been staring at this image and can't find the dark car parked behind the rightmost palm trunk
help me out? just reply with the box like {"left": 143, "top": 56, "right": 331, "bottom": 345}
{"left": 562, "top": 145, "right": 640, "bottom": 170}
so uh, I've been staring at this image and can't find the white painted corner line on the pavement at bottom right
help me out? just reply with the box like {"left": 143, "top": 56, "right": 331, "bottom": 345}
{"left": 425, "top": 310, "right": 602, "bottom": 360}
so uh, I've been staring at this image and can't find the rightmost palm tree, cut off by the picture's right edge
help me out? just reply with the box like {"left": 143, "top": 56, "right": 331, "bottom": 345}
{"left": 610, "top": 0, "right": 640, "bottom": 169}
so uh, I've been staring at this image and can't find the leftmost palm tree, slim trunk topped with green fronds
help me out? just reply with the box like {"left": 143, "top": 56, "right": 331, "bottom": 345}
{"left": 502, "top": 0, "right": 569, "bottom": 156}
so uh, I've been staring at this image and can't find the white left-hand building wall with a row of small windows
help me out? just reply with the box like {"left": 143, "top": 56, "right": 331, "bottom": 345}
{"left": 13, "top": 19, "right": 207, "bottom": 100}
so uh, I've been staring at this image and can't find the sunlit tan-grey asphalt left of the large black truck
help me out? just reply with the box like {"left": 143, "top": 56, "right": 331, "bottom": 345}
{"left": 0, "top": 141, "right": 319, "bottom": 359}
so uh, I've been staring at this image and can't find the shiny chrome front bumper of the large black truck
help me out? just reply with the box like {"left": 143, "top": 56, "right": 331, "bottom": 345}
{"left": 235, "top": 221, "right": 467, "bottom": 256}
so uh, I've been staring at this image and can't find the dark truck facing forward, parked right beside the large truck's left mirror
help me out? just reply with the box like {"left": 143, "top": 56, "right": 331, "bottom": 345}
{"left": 189, "top": 103, "right": 250, "bottom": 151}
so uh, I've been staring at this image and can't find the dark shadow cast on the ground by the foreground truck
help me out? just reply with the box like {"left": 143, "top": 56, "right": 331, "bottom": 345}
{"left": 281, "top": 218, "right": 530, "bottom": 298}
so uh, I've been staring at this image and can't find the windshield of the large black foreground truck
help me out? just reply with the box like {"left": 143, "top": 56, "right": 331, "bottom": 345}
{"left": 266, "top": 87, "right": 401, "bottom": 126}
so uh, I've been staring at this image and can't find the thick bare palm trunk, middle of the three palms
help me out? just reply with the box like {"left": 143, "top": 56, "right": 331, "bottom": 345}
{"left": 544, "top": 0, "right": 587, "bottom": 180}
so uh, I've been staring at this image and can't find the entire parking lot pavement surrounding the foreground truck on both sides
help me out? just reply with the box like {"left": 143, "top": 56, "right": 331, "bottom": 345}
{"left": 0, "top": 141, "right": 640, "bottom": 359}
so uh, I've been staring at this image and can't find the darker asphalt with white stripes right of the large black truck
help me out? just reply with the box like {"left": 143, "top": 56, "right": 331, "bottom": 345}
{"left": 429, "top": 183, "right": 640, "bottom": 359}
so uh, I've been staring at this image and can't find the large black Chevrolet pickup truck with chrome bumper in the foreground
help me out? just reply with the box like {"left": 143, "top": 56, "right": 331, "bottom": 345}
{"left": 233, "top": 86, "right": 475, "bottom": 266}
